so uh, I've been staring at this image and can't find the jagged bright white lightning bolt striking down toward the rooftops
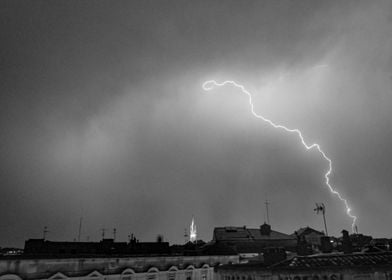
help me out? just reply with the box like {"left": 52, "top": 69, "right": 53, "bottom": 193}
{"left": 202, "top": 80, "right": 357, "bottom": 232}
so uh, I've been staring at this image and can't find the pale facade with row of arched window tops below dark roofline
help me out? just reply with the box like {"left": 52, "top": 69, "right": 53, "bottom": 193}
{"left": 0, "top": 255, "right": 238, "bottom": 280}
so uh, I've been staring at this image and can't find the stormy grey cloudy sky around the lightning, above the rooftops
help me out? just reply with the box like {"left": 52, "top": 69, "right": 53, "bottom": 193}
{"left": 0, "top": 0, "right": 392, "bottom": 246}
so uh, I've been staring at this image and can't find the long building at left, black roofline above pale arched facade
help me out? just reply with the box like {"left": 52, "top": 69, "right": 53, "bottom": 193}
{"left": 0, "top": 237, "right": 239, "bottom": 280}
